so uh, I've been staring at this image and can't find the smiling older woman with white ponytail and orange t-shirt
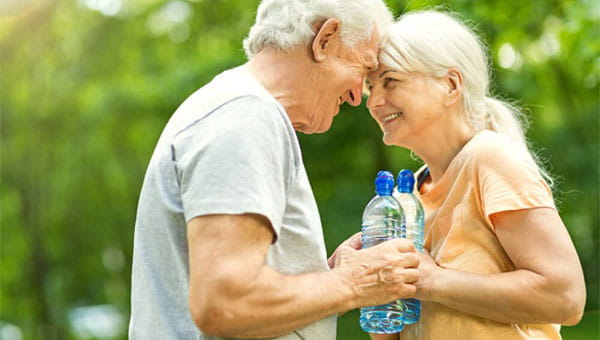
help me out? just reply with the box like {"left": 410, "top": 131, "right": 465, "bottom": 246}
{"left": 367, "top": 11, "right": 585, "bottom": 340}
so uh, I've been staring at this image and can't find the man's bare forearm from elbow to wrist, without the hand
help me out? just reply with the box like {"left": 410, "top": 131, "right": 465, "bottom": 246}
{"left": 192, "top": 266, "right": 353, "bottom": 338}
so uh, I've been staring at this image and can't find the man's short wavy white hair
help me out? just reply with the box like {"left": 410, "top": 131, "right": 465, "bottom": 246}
{"left": 244, "top": 0, "right": 393, "bottom": 59}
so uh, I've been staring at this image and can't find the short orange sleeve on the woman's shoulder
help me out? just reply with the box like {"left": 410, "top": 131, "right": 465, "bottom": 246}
{"left": 475, "top": 136, "right": 555, "bottom": 220}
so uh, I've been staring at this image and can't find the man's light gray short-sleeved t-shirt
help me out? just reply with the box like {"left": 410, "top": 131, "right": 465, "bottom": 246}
{"left": 129, "top": 67, "right": 336, "bottom": 340}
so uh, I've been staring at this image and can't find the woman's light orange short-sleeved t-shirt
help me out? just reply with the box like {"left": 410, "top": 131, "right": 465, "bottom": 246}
{"left": 401, "top": 130, "right": 561, "bottom": 340}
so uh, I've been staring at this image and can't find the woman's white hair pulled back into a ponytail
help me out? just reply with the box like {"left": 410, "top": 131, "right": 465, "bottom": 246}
{"left": 379, "top": 10, "right": 553, "bottom": 186}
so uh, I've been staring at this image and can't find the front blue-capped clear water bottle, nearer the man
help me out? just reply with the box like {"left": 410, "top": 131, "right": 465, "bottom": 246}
{"left": 360, "top": 171, "right": 404, "bottom": 334}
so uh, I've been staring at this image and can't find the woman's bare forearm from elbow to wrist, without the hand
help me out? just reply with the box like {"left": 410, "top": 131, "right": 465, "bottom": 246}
{"left": 423, "top": 268, "right": 579, "bottom": 324}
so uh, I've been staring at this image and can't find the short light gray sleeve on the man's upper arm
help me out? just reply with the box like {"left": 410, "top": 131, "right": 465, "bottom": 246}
{"left": 173, "top": 96, "right": 293, "bottom": 236}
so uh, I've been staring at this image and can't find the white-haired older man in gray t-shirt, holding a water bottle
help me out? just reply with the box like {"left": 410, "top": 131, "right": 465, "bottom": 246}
{"left": 129, "top": 0, "right": 418, "bottom": 340}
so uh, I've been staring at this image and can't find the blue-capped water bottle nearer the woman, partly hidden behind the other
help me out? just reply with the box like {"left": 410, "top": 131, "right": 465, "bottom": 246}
{"left": 394, "top": 169, "right": 425, "bottom": 325}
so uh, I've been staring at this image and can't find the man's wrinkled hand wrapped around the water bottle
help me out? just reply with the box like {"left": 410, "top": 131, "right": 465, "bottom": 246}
{"left": 329, "top": 238, "right": 419, "bottom": 308}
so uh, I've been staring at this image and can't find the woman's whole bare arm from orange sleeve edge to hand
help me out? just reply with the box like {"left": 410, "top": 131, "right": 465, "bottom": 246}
{"left": 417, "top": 208, "right": 586, "bottom": 325}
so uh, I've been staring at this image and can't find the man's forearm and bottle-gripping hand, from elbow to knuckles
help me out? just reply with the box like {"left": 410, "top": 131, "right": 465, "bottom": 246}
{"left": 190, "top": 239, "right": 419, "bottom": 337}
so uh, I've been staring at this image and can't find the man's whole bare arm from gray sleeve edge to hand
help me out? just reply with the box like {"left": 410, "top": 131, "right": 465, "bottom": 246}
{"left": 188, "top": 214, "right": 418, "bottom": 337}
